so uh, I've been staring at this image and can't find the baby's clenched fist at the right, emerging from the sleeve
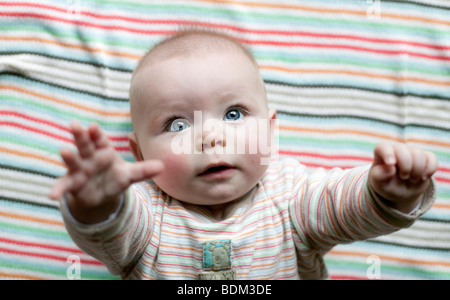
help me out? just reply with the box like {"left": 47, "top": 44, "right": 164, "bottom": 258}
{"left": 369, "top": 143, "right": 438, "bottom": 213}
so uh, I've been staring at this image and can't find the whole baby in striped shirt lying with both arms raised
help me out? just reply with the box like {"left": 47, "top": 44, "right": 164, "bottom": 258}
{"left": 50, "top": 31, "right": 437, "bottom": 279}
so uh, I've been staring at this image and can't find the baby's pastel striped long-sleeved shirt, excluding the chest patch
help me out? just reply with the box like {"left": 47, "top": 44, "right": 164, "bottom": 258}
{"left": 62, "top": 159, "right": 434, "bottom": 279}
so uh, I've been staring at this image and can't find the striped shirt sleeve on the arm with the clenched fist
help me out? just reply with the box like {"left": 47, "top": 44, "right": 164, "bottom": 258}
{"left": 291, "top": 166, "right": 435, "bottom": 253}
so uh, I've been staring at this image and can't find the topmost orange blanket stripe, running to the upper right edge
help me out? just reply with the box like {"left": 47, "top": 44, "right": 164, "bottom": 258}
{"left": 197, "top": 0, "right": 450, "bottom": 26}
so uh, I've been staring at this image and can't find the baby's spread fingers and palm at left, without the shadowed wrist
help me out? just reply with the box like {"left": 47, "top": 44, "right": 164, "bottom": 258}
{"left": 50, "top": 122, "right": 164, "bottom": 203}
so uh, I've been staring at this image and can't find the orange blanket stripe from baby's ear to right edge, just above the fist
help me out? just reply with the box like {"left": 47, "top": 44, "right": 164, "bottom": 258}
{"left": 279, "top": 125, "right": 450, "bottom": 147}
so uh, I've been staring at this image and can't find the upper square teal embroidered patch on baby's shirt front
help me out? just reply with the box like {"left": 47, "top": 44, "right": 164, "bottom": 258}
{"left": 203, "top": 240, "right": 231, "bottom": 271}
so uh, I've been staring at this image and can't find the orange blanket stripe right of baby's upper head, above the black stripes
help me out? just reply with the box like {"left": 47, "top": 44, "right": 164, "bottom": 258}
{"left": 260, "top": 65, "right": 450, "bottom": 86}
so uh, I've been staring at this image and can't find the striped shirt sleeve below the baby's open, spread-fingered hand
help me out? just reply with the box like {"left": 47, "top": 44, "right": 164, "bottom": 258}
{"left": 60, "top": 185, "right": 152, "bottom": 275}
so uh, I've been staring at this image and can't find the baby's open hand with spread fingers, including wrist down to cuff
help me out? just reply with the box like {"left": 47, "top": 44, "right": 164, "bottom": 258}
{"left": 50, "top": 122, "right": 164, "bottom": 224}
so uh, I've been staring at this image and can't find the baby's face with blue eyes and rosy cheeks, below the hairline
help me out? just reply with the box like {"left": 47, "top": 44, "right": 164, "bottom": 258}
{"left": 130, "top": 52, "right": 275, "bottom": 205}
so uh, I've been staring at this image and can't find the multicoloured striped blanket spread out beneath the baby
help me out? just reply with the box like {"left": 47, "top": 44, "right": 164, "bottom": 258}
{"left": 0, "top": 0, "right": 450, "bottom": 279}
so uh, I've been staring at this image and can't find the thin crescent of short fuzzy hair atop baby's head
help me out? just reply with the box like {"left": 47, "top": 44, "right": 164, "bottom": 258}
{"left": 134, "top": 29, "right": 258, "bottom": 77}
